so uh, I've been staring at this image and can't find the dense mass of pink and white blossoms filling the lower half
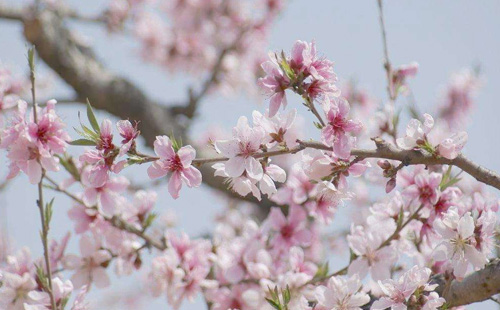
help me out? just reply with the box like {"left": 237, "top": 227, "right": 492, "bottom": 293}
{"left": 0, "top": 37, "right": 500, "bottom": 310}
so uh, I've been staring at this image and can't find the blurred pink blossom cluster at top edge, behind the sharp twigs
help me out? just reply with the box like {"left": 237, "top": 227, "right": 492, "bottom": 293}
{"left": 106, "top": 0, "right": 285, "bottom": 93}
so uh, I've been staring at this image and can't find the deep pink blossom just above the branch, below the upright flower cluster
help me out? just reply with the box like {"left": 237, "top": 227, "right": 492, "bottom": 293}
{"left": 321, "top": 98, "right": 363, "bottom": 158}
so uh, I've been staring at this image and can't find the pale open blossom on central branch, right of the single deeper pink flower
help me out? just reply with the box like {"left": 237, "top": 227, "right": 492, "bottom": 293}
{"left": 215, "top": 116, "right": 265, "bottom": 181}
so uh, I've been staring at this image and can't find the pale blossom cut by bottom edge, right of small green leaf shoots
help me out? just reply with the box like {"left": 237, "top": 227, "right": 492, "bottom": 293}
{"left": 314, "top": 275, "right": 370, "bottom": 310}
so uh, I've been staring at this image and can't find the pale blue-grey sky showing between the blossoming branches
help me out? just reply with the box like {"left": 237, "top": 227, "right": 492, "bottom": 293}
{"left": 0, "top": 0, "right": 500, "bottom": 310}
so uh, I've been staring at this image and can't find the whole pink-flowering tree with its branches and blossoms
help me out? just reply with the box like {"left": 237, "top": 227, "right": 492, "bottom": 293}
{"left": 0, "top": 0, "right": 500, "bottom": 310}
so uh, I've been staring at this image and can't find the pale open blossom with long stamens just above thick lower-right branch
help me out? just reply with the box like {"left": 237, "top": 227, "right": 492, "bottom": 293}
{"left": 434, "top": 207, "right": 488, "bottom": 280}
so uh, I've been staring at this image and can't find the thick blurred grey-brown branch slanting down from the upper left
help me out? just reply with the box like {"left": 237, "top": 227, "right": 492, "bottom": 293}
{"left": 0, "top": 6, "right": 278, "bottom": 213}
